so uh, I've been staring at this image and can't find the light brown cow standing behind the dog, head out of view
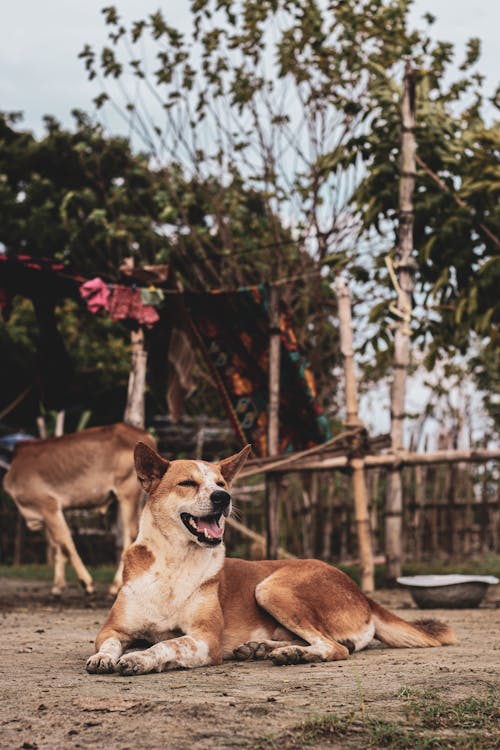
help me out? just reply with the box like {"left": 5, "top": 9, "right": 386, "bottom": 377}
{"left": 3, "top": 423, "right": 155, "bottom": 595}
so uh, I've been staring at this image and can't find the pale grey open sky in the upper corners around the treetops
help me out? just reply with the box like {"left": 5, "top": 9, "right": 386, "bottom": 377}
{"left": 0, "top": 0, "right": 500, "bottom": 134}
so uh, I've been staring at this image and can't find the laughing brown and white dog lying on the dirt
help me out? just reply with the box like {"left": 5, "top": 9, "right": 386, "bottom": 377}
{"left": 87, "top": 443, "right": 455, "bottom": 675}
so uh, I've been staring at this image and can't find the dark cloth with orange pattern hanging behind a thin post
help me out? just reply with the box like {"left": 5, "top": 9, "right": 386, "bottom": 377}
{"left": 186, "top": 286, "right": 331, "bottom": 456}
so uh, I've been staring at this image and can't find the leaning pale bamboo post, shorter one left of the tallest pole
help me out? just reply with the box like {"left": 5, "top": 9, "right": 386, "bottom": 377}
{"left": 336, "top": 276, "right": 375, "bottom": 594}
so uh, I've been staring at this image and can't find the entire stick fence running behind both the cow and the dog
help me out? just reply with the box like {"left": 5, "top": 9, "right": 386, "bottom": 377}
{"left": 0, "top": 459, "right": 500, "bottom": 569}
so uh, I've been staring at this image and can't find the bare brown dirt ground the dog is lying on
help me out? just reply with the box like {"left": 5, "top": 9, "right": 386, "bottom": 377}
{"left": 0, "top": 579, "right": 500, "bottom": 750}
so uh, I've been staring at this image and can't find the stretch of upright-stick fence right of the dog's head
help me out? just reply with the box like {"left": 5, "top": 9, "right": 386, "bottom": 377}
{"left": 229, "top": 463, "right": 500, "bottom": 562}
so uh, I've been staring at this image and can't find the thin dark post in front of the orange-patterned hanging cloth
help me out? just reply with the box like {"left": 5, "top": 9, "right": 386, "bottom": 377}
{"left": 266, "top": 284, "right": 281, "bottom": 560}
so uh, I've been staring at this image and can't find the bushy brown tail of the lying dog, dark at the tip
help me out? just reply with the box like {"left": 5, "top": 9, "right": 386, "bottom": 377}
{"left": 367, "top": 597, "right": 457, "bottom": 648}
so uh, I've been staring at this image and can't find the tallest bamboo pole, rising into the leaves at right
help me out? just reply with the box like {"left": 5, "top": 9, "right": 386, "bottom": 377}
{"left": 385, "top": 61, "right": 416, "bottom": 584}
